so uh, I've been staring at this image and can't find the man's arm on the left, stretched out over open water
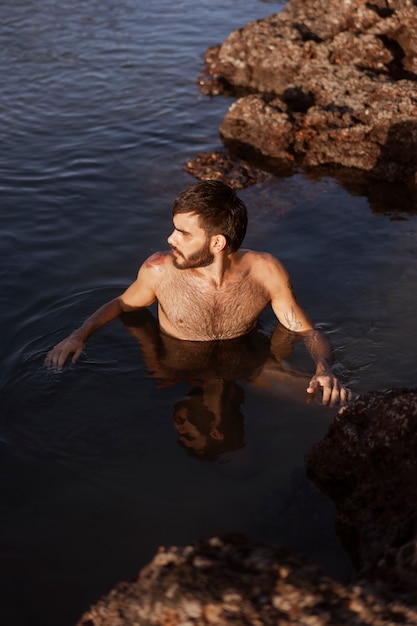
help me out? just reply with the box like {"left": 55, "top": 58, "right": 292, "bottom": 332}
{"left": 46, "top": 255, "right": 160, "bottom": 369}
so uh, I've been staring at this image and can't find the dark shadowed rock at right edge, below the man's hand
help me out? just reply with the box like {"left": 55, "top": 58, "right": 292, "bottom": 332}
{"left": 306, "top": 389, "right": 417, "bottom": 606}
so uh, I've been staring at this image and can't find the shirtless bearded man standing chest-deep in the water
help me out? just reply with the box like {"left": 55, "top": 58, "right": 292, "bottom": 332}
{"left": 46, "top": 181, "right": 351, "bottom": 406}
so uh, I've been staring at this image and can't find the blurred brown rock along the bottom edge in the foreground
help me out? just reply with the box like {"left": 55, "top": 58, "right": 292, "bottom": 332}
{"left": 77, "top": 536, "right": 417, "bottom": 626}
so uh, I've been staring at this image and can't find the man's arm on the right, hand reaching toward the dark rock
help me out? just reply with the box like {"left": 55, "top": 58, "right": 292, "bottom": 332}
{"left": 266, "top": 255, "right": 352, "bottom": 406}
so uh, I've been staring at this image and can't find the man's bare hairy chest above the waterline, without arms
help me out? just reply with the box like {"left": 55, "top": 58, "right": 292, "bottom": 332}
{"left": 151, "top": 252, "right": 270, "bottom": 341}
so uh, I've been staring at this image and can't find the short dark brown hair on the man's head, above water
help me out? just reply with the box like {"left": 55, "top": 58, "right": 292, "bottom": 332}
{"left": 172, "top": 180, "right": 248, "bottom": 252}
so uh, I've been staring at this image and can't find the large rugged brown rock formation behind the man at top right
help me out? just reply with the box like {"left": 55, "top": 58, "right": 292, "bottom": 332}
{"left": 187, "top": 0, "right": 417, "bottom": 183}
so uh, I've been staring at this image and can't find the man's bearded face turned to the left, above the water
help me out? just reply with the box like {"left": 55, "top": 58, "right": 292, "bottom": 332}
{"left": 168, "top": 213, "right": 214, "bottom": 270}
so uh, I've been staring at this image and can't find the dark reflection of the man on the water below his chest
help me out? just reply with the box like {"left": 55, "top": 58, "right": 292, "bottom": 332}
{"left": 122, "top": 309, "right": 298, "bottom": 461}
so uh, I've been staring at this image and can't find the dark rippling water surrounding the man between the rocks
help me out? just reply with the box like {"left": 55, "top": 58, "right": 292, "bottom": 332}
{"left": 0, "top": 0, "right": 417, "bottom": 626}
